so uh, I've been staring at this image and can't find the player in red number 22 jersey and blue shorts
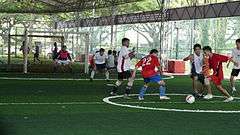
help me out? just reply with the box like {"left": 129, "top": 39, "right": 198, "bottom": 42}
{"left": 132, "top": 49, "right": 170, "bottom": 100}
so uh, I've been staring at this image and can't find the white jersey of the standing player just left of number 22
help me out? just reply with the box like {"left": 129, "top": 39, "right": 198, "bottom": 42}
{"left": 117, "top": 46, "right": 131, "bottom": 73}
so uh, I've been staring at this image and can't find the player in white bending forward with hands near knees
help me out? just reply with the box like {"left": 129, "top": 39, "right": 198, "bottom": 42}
{"left": 90, "top": 48, "right": 109, "bottom": 81}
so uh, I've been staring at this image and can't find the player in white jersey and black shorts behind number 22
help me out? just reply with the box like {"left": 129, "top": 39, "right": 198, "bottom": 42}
{"left": 110, "top": 38, "right": 135, "bottom": 99}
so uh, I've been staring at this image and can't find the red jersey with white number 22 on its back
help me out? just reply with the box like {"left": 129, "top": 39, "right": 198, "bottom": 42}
{"left": 135, "top": 55, "right": 160, "bottom": 78}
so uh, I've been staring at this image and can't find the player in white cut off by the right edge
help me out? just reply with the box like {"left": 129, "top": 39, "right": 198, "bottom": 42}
{"left": 227, "top": 39, "right": 240, "bottom": 92}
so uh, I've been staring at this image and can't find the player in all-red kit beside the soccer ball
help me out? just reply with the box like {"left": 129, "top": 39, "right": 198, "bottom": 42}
{"left": 203, "top": 46, "right": 238, "bottom": 102}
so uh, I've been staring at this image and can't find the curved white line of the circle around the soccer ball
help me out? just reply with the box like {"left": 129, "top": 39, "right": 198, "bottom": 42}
{"left": 103, "top": 93, "right": 240, "bottom": 113}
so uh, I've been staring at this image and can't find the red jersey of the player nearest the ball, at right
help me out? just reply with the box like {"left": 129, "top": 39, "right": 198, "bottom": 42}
{"left": 209, "top": 53, "right": 229, "bottom": 81}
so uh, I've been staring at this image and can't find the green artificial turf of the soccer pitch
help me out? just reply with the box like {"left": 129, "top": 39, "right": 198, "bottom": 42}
{"left": 0, "top": 77, "right": 240, "bottom": 135}
